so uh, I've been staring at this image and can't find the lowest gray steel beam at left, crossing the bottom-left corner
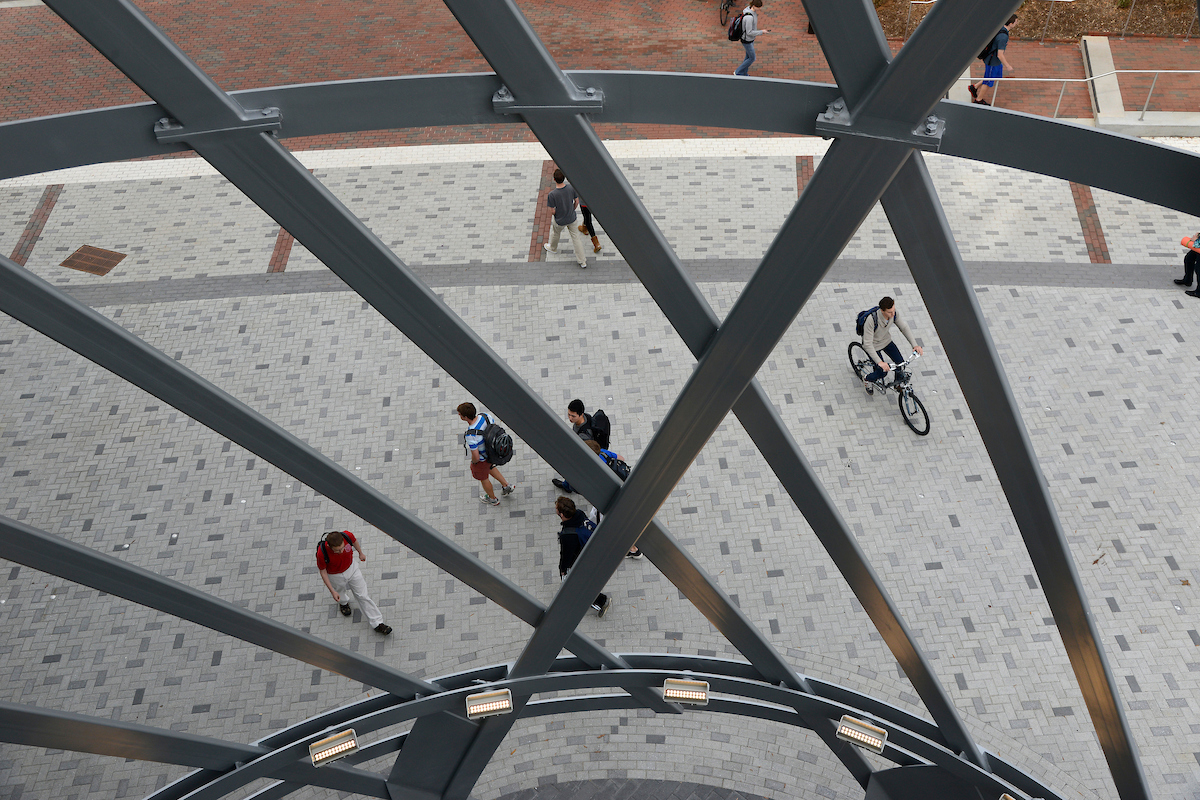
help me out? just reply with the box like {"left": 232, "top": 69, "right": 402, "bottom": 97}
{"left": 0, "top": 702, "right": 388, "bottom": 800}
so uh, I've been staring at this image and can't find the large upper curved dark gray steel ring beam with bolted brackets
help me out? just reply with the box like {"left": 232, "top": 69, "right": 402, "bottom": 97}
{"left": 0, "top": 71, "right": 1200, "bottom": 216}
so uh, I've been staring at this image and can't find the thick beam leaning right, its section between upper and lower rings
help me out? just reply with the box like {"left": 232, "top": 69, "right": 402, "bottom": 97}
{"left": 512, "top": 131, "right": 907, "bottom": 695}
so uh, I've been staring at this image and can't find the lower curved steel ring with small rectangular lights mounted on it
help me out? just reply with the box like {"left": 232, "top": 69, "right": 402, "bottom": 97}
{"left": 133, "top": 654, "right": 1062, "bottom": 800}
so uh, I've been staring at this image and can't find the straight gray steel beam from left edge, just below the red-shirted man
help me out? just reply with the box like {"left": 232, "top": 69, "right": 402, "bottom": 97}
{"left": 0, "top": 516, "right": 442, "bottom": 697}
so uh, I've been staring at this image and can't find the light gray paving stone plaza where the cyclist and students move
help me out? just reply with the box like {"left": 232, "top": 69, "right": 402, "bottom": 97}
{"left": 7, "top": 139, "right": 1200, "bottom": 800}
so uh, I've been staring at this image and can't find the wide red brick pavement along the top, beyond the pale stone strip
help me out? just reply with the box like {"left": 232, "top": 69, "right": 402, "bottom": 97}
{"left": 0, "top": 0, "right": 1200, "bottom": 150}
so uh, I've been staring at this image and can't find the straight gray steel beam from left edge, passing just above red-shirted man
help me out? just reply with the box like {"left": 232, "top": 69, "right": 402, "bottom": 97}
{"left": 0, "top": 250, "right": 620, "bottom": 667}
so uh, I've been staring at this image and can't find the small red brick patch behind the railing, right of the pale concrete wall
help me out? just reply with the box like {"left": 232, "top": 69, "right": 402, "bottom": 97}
{"left": 1109, "top": 38, "right": 1200, "bottom": 112}
